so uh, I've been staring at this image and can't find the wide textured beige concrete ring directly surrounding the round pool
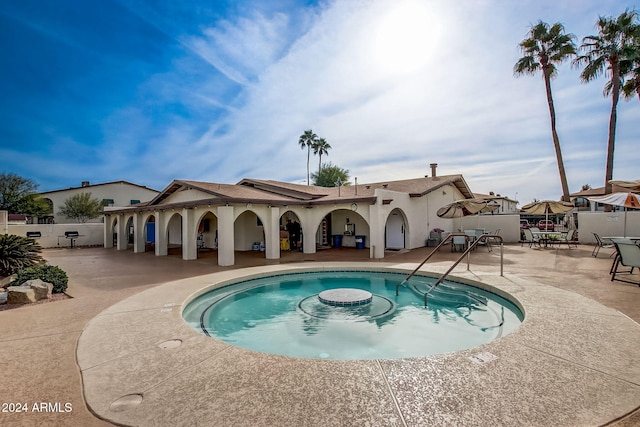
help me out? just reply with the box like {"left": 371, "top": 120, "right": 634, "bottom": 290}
{"left": 77, "top": 262, "right": 640, "bottom": 426}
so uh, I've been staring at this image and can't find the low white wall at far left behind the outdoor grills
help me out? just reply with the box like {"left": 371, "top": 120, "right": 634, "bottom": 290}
{"left": 8, "top": 223, "right": 104, "bottom": 248}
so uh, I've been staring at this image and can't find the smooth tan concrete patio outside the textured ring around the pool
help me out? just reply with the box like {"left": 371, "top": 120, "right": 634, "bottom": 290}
{"left": 0, "top": 245, "right": 640, "bottom": 427}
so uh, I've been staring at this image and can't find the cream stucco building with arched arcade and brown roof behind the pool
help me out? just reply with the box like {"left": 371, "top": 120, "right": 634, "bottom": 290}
{"left": 104, "top": 175, "right": 517, "bottom": 266}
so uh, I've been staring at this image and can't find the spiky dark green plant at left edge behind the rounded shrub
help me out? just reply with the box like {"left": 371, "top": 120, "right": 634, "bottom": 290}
{"left": 0, "top": 234, "right": 44, "bottom": 277}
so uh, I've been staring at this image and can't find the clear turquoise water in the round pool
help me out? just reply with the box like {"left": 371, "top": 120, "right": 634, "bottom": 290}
{"left": 183, "top": 271, "right": 523, "bottom": 360}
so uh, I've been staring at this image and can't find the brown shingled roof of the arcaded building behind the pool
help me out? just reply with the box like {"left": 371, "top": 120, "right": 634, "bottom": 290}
{"left": 109, "top": 175, "right": 473, "bottom": 212}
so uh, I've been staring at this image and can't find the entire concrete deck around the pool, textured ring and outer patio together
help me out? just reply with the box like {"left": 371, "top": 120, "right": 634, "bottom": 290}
{"left": 0, "top": 245, "right": 640, "bottom": 427}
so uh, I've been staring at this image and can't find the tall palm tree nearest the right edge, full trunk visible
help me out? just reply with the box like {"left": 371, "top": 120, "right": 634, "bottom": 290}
{"left": 574, "top": 10, "right": 638, "bottom": 194}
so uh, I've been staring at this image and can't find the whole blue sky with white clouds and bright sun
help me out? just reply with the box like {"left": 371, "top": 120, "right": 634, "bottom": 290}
{"left": 0, "top": 0, "right": 640, "bottom": 205}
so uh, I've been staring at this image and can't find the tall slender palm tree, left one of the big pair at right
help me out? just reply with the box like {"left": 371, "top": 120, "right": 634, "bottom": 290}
{"left": 513, "top": 21, "right": 576, "bottom": 202}
